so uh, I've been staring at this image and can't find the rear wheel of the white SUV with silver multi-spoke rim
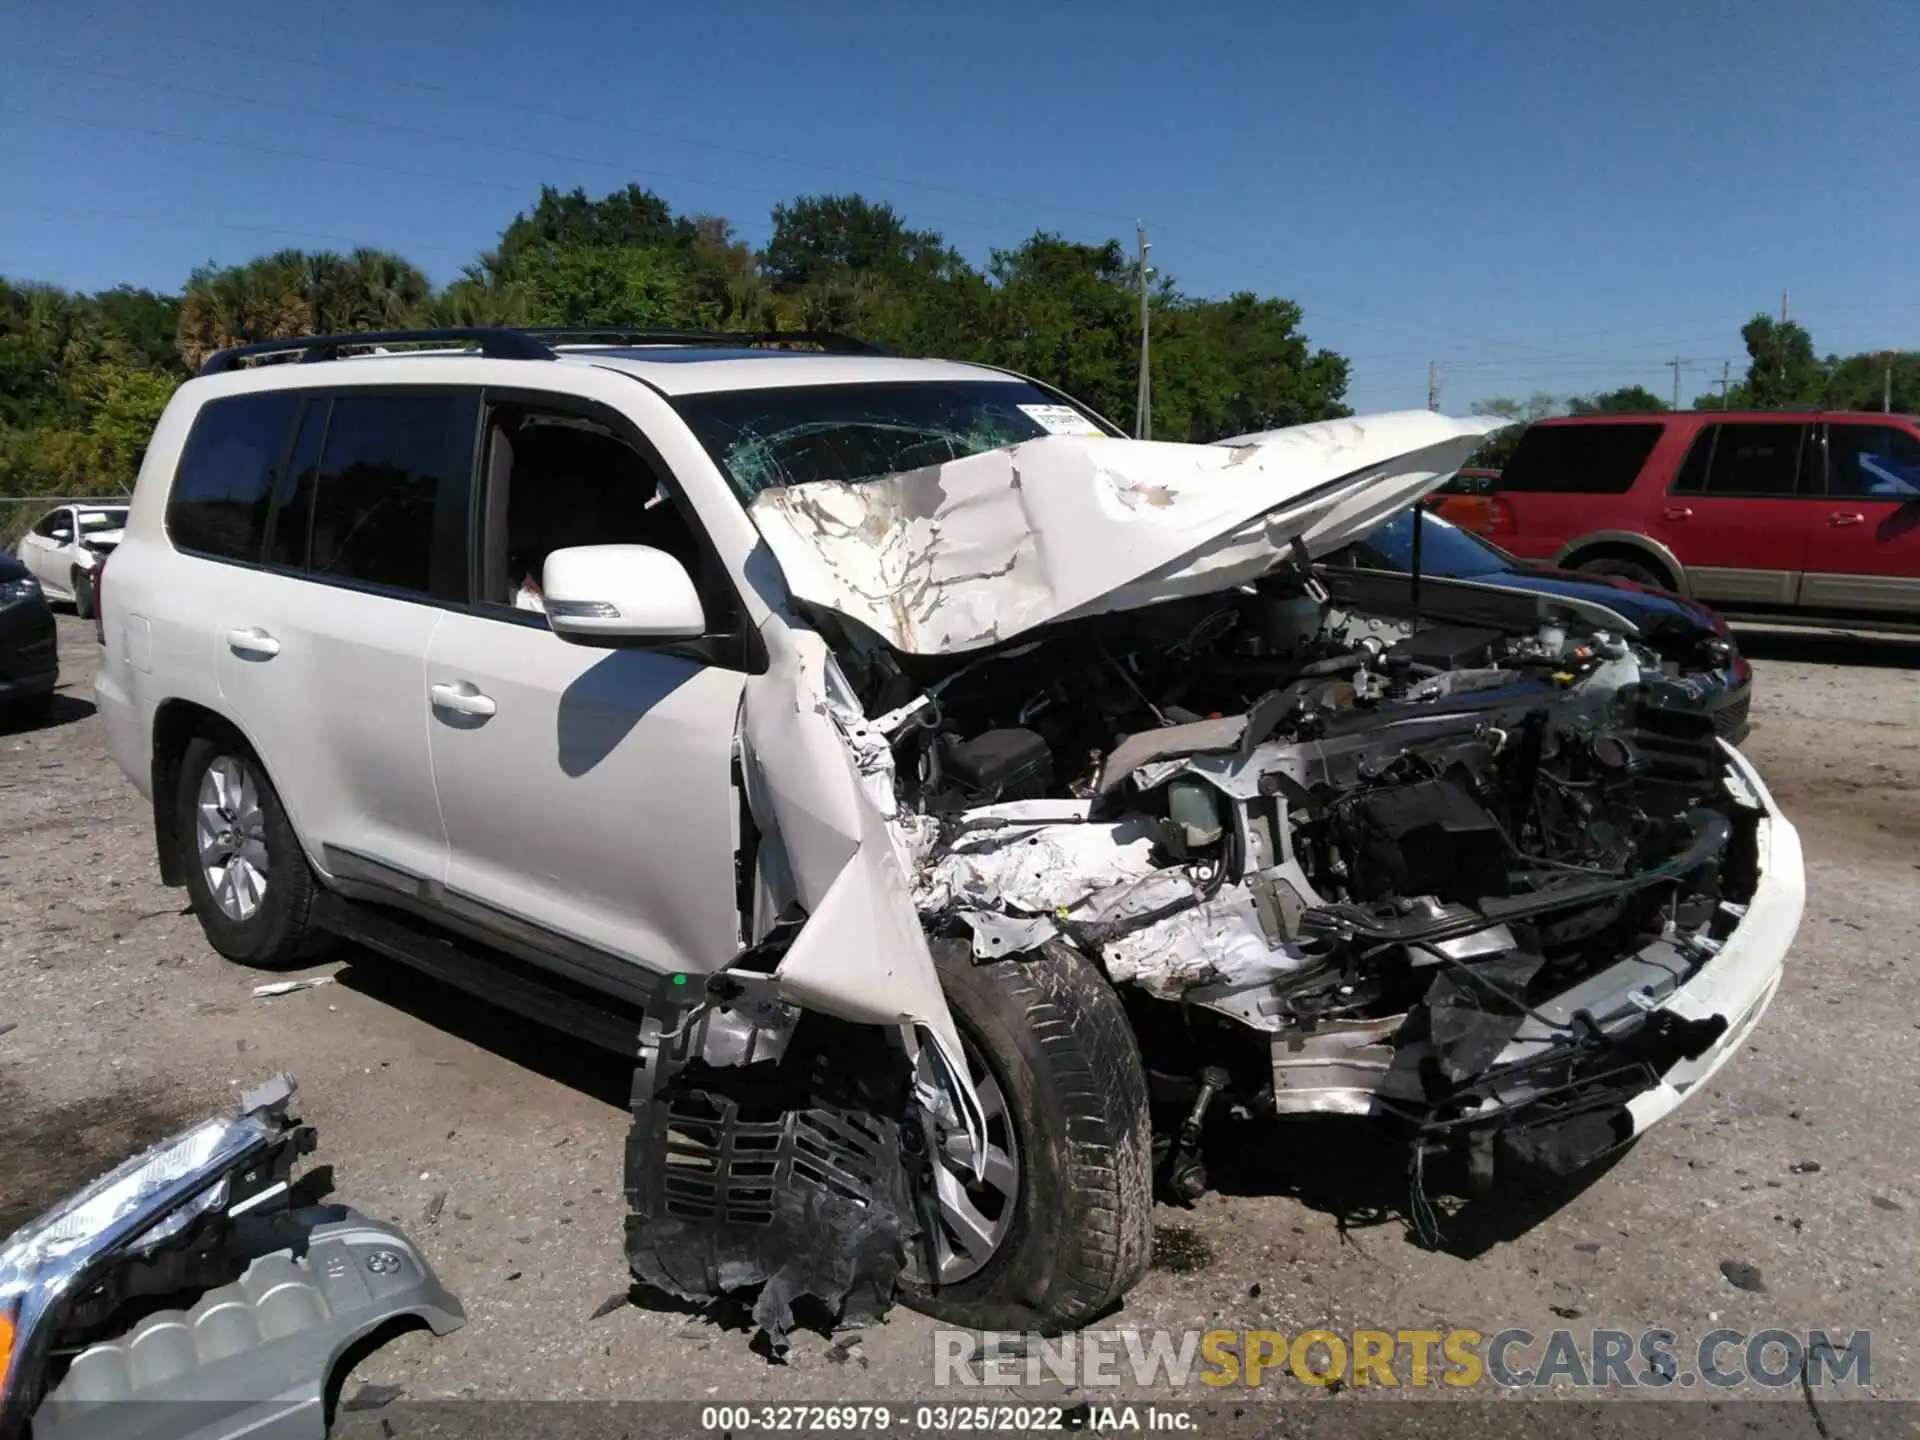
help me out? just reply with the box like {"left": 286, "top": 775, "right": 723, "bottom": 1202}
{"left": 175, "top": 735, "right": 321, "bottom": 970}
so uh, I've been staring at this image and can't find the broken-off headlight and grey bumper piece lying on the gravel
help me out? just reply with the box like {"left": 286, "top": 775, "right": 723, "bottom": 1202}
{"left": 0, "top": 1075, "right": 465, "bottom": 1440}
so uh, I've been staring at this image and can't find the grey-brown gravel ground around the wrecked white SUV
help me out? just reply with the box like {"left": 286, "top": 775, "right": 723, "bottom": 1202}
{"left": 0, "top": 616, "right": 1920, "bottom": 1434}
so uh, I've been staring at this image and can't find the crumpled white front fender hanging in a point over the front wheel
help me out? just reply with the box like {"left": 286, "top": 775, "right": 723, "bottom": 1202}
{"left": 741, "top": 614, "right": 987, "bottom": 1156}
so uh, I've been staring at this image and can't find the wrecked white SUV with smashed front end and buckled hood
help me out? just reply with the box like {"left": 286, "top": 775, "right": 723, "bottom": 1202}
{"left": 98, "top": 330, "right": 1803, "bottom": 1340}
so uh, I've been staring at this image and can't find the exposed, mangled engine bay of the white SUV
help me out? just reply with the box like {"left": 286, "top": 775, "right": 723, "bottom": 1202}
{"left": 817, "top": 574, "right": 1757, "bottom": 1188}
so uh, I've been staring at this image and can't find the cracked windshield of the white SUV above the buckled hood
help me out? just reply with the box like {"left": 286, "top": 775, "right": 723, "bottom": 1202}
{"left": 674, "top": 380, "right": 1106, "bottom": 505}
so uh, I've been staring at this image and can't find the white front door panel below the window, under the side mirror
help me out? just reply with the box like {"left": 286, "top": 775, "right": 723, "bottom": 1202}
{"left": 422, "top": 612, "right": 745, "bottom": 973}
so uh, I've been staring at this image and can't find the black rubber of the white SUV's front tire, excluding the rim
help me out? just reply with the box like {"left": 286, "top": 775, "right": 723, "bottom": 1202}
{"left": 904, "top": 941, "right": 1154, "bottom": 1332}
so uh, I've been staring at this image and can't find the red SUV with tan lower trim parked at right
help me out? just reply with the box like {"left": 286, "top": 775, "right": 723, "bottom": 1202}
{"left": 1486, "top": 411, "right": 1920, "bottom": 628}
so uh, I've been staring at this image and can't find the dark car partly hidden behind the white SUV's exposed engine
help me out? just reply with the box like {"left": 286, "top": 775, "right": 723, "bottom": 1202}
{"left": 1321, "top": 511, "right": 1753, "bottom": 743}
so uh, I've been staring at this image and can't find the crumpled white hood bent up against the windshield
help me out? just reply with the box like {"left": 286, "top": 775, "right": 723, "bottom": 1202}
{"left": 751, "top": 411, "right": 1505, "bottom": 655}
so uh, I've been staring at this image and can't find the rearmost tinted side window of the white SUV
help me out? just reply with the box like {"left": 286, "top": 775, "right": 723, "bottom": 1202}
{"left": 167, "top": 390, "right": 300, "bottom": 561}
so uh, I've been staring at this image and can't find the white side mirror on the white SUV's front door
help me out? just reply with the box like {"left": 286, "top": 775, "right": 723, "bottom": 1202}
{"left": 540, "top": 545, "right": 707, "bottom": 647}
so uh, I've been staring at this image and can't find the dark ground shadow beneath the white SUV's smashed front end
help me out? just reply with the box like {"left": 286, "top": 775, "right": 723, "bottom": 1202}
{"left": 1206, "top": 1116, "right": 1632, "bottom": 1260}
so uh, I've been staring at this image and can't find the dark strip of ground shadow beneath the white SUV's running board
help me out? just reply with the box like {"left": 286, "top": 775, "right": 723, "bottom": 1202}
{"left": 334, "top": 960, "right": 634, "bottom": 1112}
